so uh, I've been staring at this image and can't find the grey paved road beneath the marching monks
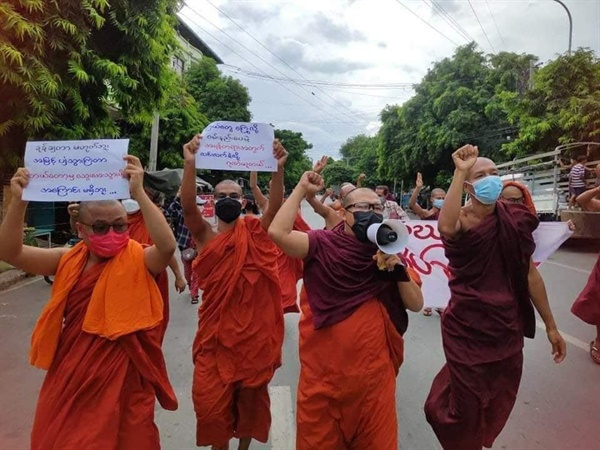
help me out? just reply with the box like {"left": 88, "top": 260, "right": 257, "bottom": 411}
{"left": 0, "top": 203, "right": 600, "bottom": 450}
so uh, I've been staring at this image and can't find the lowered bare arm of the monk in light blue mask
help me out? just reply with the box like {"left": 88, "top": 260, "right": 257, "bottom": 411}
{"left": 527, "top": 260, "right": 567, "bottom": 363}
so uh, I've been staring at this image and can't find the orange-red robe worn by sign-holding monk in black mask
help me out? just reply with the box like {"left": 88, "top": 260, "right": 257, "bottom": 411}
{"left": 192, "top": 216, "right": 283, "bottom": 446}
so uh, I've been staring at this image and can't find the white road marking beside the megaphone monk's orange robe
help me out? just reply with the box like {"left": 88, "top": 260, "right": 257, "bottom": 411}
{"left": 269, "top": 386, "right": 296, "bottom": 450}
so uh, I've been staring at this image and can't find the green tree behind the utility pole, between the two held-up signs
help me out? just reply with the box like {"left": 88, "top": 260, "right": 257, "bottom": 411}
{"left": 123, "top": 71, "right": 209, "bottom": 170}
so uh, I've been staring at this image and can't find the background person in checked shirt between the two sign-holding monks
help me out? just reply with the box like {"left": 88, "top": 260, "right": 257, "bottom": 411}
{"left": 167, "top": 190, "right": 207, "bottom": 305}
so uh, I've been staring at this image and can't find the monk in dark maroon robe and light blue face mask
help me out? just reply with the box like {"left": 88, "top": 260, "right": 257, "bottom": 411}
{"left": 425, "top": 145, "right": 566, "bottom": 450}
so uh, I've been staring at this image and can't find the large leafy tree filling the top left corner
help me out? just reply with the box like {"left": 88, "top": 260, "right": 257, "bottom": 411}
{"left": 0, "top": 0, "right": 178, "bottom": 174}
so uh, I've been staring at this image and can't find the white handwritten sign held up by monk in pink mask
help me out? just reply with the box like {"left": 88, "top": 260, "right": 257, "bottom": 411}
{"left": 23, "top": 139, "right": 129, "bottom": 202}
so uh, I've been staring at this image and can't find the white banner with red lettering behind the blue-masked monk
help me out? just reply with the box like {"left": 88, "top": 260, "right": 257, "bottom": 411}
{"left": 402, "top": 220, "right": 573, "bottom": 308}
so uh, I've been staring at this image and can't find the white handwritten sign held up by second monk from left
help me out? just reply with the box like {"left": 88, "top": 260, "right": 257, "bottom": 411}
{"left": 196, "top": 122, "right": 277, "bottom": 172}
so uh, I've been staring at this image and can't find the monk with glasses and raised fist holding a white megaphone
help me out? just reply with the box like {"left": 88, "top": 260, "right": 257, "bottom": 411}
{"left": 269, "top": 172, "right": 423, "bottom": 450}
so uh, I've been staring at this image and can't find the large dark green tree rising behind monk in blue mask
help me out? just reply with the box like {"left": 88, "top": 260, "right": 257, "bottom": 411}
{"left": 378, "top": 44, "right": 535, "bottom": 188}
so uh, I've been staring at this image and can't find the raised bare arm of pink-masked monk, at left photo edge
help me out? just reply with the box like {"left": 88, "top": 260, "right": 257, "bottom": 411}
{"left": 0, "top": 169, "right": 68, "bottom": 275}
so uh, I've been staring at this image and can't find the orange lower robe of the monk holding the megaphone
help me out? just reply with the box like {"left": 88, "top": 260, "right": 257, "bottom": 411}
{"left": 296, "top": 287, "right": 404, "bottom": 450}
